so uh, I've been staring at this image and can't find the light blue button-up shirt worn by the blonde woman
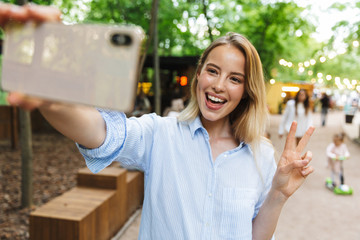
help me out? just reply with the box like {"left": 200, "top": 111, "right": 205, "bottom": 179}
{"left": 79, "top": 110, "right": 276, "bottom": 240}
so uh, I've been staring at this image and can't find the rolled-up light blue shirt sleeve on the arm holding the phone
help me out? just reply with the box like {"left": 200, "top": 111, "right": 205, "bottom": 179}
{"left": 77, "top": 109, "right": 158, "bottom": 173}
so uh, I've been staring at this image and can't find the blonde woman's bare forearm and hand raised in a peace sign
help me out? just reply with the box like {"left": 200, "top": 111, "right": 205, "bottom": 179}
{"left": 253, "top": 122, "right": 314, "bottom": 240}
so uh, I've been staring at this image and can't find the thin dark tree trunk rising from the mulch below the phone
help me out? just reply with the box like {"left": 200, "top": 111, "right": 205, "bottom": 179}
{"left": 16, "top": 0, "right": 33, "bottom": 208}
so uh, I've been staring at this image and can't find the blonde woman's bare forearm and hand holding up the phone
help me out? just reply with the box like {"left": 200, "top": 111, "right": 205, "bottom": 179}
{"left": 0, "top": 3, "right": 106, "bottom": 148}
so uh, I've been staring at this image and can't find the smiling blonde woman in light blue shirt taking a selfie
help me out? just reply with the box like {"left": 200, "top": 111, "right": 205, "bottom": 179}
{"left": 0, "top": 2, "right": 314, "bottom": 240}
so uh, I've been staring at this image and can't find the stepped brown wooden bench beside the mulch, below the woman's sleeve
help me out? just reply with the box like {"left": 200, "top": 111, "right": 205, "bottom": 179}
{"left": 30, "top": 167, "right": 143, "bottom": 240}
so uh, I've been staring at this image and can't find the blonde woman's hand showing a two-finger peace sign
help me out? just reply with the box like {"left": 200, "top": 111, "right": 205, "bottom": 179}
{"left": 272, "top": 121, "right": 315, "bottom": 199}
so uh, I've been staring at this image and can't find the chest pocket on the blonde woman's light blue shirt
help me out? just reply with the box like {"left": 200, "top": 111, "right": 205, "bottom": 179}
{"left": 220, "top": 188, "right": 257, "bottom": 239}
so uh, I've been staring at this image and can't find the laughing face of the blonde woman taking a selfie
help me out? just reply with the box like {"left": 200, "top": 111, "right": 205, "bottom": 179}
{"left": 196, "top": 45, "right": 245, "bottom": 124}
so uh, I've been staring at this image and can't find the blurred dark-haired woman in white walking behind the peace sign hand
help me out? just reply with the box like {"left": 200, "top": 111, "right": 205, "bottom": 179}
{"left": 279, "top": 89, "right": 312, "bottom": 143}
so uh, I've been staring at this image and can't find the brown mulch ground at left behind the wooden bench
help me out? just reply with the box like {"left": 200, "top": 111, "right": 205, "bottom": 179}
{"left": 0, "top": 133, "right": 85, "bottom": 240}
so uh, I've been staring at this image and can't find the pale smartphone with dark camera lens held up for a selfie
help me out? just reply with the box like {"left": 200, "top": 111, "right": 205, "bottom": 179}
{"left": 1, "top": 22, "right": 145, "bottom": 112}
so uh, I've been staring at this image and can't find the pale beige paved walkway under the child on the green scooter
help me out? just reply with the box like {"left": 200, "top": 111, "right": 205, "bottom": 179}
{"left": 119, "top": 112, "right": 360, "bottom": 240}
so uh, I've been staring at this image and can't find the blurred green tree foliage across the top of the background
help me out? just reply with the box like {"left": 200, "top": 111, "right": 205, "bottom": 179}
{"left": 4, "top": 0, "right": 354, "bottom": 85}
